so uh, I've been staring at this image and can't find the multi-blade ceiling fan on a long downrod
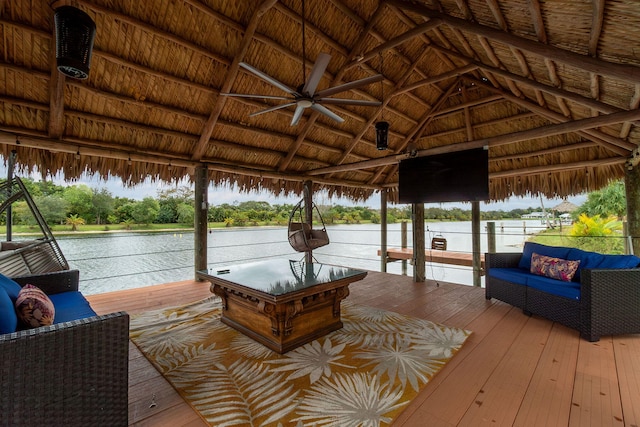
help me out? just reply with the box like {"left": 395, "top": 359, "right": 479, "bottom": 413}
{"left": 222, "top": 1, "right": 384, "bottom": 126}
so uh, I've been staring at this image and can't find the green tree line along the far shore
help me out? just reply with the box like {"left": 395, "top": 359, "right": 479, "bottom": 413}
{"left": 3, "top": 178, "right": 626, "bottom": 231}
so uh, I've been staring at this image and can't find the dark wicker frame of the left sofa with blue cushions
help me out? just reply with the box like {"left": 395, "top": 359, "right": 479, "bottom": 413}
{"left": 0, "top": 270, "right": 129, "bottom": 427}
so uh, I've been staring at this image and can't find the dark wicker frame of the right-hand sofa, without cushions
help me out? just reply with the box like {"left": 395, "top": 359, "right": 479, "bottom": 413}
{"left": 485, "top": 253, "right": 640, "bottom": 342}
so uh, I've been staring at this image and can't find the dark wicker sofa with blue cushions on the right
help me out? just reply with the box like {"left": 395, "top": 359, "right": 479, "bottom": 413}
{"left": 485, "top": 242, "right": 640, "bottom": 341}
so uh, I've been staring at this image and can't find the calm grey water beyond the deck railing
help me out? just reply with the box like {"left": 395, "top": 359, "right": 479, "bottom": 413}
{"left": 57, "top": 220, "right": 543, "bottom": 294}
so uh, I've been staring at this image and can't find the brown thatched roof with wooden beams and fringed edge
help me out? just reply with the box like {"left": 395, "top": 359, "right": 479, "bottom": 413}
{"left": 0, "top": 0, "right": 640, "bottom": 204}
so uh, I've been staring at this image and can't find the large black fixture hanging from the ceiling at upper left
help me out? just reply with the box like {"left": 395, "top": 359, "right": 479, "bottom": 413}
{"left": 54, "top": 6, "right": 96, "bottom": 80}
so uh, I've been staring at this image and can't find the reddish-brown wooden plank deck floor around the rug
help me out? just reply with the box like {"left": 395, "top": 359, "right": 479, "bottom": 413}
{"left": 89, "top": 272, "right": 640, "bottom": 427}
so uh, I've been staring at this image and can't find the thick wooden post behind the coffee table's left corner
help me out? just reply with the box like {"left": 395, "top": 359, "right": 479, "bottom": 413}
{"left": 193, "top": 165, "right": 209, "bottom": 281}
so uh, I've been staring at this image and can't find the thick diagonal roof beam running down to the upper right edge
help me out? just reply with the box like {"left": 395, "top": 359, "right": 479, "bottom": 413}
{"left": 387, "top": 0, "right": 640, "bottom": 84}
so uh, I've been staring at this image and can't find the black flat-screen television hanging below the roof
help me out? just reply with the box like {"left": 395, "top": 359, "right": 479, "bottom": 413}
{"left": 398, "top": 148, "right": 489, "bottom": 203}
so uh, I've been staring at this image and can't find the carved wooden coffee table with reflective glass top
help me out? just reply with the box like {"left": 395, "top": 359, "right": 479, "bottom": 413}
{"left": 197, "top": 259, "right": 367, "bottom": 354}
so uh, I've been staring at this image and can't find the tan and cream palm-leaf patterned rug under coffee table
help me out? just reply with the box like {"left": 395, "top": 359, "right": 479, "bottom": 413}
{"left": 130, "top": 297, "right": 470, "bottom": 427}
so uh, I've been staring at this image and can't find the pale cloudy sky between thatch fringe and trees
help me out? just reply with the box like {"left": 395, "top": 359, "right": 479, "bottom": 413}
{"left": 0, "top": 164, "right": 587, "bottom": 211}
